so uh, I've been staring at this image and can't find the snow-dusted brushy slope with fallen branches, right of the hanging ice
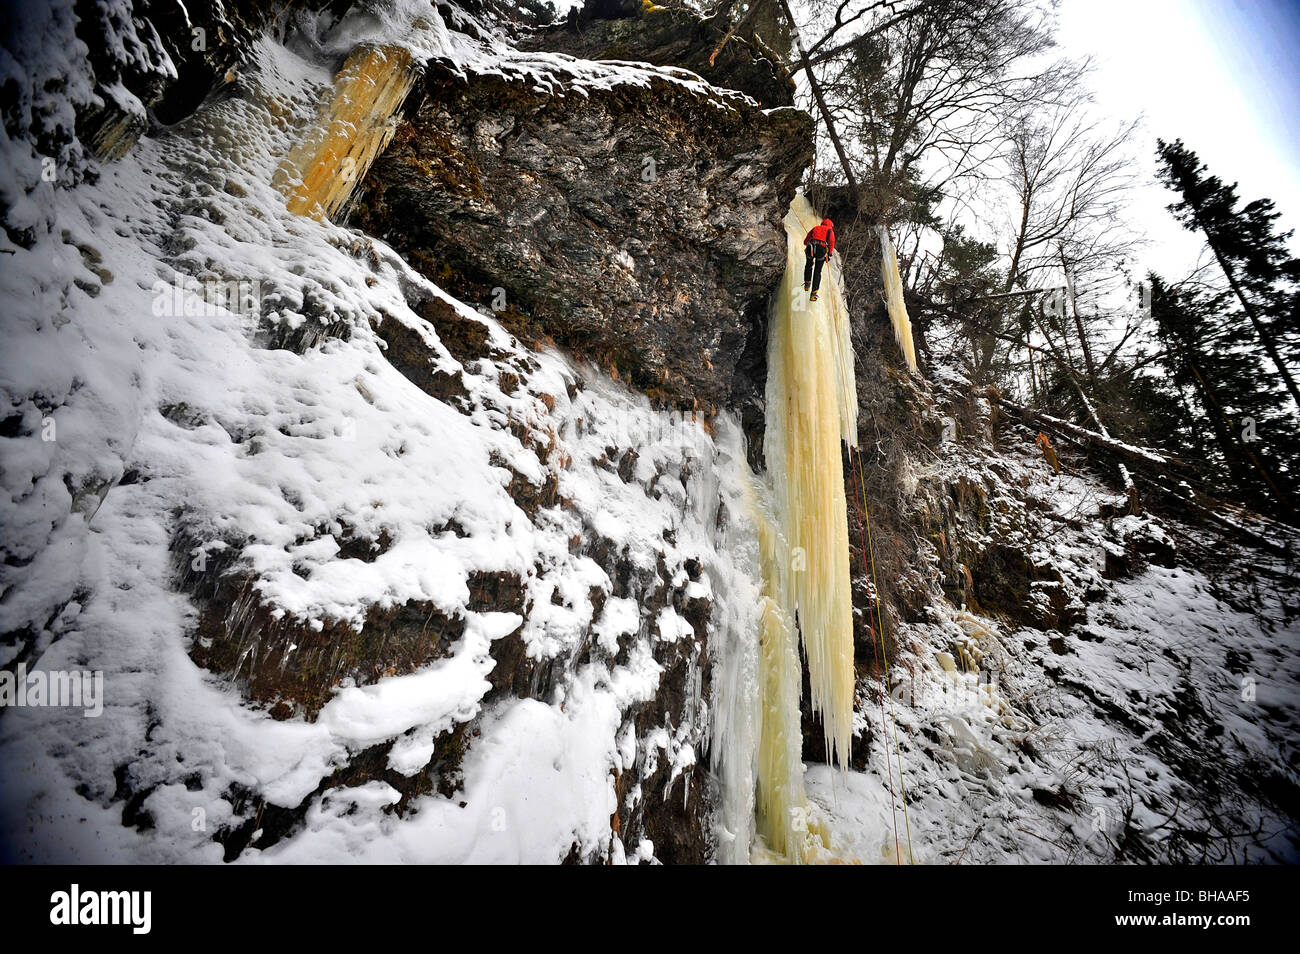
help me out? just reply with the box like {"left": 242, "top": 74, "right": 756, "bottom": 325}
{"left": 809, "top": 435, "right": 1300, "bottom": 864}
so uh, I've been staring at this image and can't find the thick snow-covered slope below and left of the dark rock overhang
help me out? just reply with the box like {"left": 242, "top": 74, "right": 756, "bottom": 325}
{"left": 0, "top": 0, "right": 753, "bottom": 862}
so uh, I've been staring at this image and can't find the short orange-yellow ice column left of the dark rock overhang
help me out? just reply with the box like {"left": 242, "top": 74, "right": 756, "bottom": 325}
{"left": 274, "top": 45, "right": 419, "bottom": 218}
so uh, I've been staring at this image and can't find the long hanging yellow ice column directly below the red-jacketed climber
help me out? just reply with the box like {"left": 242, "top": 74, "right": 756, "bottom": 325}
{"left": 761, "top": 195, "right": 857, "bottom": 764}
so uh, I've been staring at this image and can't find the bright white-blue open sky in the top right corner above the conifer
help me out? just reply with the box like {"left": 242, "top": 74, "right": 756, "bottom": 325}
{"left": 1060, "top": 0, "right": 1300, "bottom": 279}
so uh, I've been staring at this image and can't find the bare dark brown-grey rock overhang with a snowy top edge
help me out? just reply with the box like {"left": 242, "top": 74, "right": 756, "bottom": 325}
{"left": 350, "top": 55, "right": 811, "bottom": 412}
